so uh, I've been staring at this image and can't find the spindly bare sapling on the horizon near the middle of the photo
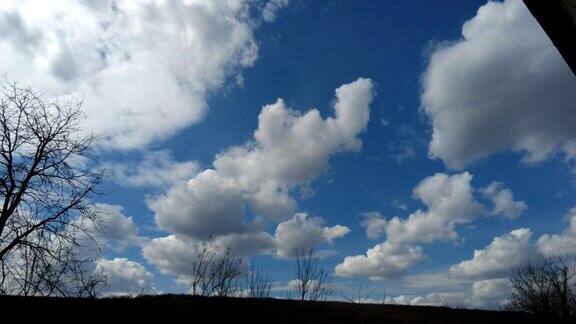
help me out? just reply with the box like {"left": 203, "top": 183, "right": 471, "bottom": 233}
{"left": 294, "top": 248, "right": 334, "bottom": 301}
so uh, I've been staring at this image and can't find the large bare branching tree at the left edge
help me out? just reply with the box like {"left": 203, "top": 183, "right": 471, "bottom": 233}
{"left": 0, "top": 80, "right": 103, "bottom": 296}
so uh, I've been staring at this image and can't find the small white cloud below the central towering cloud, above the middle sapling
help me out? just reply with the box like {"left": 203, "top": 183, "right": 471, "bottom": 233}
{"left": 274, "top": 213, "right": 350, "bottom": 258}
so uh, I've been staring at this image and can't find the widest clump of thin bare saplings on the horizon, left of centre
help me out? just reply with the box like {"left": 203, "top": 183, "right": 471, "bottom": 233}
{"left": 190, "top": 238, "right": 242, "bottom": 296}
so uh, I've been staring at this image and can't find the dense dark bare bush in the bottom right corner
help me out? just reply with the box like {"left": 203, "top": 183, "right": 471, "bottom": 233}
{"left": 506, "top": 257, "right": 576, "bottom": 319}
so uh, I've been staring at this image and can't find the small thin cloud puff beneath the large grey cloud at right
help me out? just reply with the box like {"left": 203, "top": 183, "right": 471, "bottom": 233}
{"left": 480, "top": 181, "right": 528, "bottom": 219}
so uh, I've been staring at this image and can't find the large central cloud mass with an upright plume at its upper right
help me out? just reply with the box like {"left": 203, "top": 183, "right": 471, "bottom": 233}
{"left": 143, "top": 78, "right": 373, "bottom": 276}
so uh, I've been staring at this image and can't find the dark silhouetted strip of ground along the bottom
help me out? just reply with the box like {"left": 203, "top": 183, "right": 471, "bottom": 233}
{"left": 0, "top": 295, "right": 551, "bottom": 324}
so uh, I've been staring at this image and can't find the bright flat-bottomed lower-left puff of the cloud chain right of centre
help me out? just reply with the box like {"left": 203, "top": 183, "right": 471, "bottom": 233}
{"left": 335, "top": 241, "right": 424, "bottom": 279}
